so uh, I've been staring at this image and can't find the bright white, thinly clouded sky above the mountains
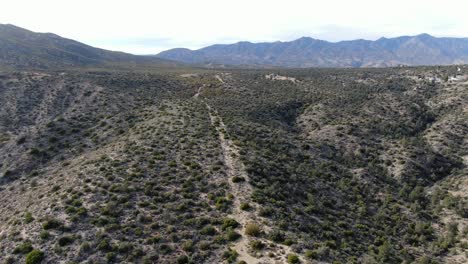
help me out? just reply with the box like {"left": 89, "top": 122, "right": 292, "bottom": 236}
{"left": 0, "top": 0, "right": 468, "bottom": 54}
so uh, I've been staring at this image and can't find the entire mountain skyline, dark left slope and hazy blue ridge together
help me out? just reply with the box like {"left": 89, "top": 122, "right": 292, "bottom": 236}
{"left": 0, "top": 24, "right": 468, "bottom": 69}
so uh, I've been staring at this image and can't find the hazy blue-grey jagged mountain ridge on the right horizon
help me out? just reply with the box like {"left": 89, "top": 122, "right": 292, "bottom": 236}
{"left": 156, "top": 34, "right": 468, "bottom": 68}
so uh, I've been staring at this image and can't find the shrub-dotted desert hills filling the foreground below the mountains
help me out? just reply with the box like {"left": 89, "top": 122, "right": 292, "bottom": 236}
{"left": 0, "top": 67, "right": 468, "bottom": 263}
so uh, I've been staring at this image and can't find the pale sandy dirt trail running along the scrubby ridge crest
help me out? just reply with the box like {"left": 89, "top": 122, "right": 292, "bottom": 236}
{"left": 194, "top": 75, "right": 306, "bottom": 264}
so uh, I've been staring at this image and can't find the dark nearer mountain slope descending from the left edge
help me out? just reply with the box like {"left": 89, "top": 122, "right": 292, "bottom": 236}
{"left": 0, "top": 24, "right": 176, "bottom": 69}
